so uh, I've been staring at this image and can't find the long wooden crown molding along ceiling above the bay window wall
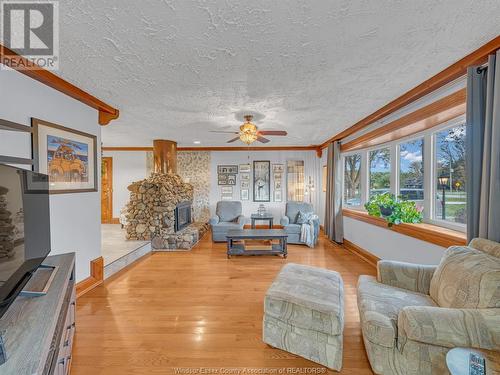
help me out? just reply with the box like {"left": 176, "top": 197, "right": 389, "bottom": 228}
{"left": 321, "top": 36, "right": 500, "bottom": 148}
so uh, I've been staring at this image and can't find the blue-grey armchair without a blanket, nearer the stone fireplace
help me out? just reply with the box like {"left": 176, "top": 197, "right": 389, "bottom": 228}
{"left": 209, "top": 201, "right": 245, "bottom": 242}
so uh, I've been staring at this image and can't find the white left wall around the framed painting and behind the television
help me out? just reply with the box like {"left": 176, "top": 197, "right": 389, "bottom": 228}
{"left": 0, "top": 70, "right": 101, "bottom": 281}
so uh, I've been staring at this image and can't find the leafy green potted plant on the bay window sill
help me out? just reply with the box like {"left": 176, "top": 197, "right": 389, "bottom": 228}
{"left": 365, "top": 193, "right": 423, "bottom": 226}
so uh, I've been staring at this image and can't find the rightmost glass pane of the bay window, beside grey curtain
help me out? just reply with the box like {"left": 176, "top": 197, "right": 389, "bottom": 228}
{"left": 434, "top": 125, "right": 467, "bottom": 224}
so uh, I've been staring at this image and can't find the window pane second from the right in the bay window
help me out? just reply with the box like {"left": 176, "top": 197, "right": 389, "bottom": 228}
{"left": 399, "top": 138, "right": 424, "bottom": 209}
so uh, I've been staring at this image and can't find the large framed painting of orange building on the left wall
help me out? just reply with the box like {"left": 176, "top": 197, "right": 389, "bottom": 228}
{"left": 31, "top": 118, "right": 98, "bottom": 194}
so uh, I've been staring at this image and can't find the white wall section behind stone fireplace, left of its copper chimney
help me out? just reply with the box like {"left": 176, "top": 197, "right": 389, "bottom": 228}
{"left": 103, "top": 151, "right": 147, "bottom": 218}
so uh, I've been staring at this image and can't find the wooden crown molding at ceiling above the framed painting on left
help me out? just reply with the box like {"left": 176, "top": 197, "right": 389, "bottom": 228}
{"left": 0, "top": 44, "right": 120, "bottom": 125}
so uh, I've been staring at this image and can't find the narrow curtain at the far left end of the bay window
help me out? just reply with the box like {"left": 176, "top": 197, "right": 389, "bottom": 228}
{"left": 325, "top": 141, "right": 344, "bottom": 243}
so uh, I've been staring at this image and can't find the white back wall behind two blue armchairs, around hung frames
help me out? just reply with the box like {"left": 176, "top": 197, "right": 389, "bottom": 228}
{"left": 210, "top": 151, "right": 322, "bottom": 224}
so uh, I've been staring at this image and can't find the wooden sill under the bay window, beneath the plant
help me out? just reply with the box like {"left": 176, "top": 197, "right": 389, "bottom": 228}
{"left": 342, "top": 209, "right": 467, "bottom": 247}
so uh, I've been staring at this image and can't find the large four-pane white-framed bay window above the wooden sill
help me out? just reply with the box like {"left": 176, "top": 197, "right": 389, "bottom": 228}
{"left": 343, "top": 116, "right": 467, "bottom": 231}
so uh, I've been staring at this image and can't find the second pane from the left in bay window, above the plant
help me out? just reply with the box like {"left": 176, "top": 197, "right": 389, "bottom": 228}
{"left": 369, "top": 148, "right": 391, "bottom": 197}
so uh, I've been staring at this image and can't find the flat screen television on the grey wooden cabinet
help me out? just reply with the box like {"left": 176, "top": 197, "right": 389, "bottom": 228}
{"left": 0, "top": 164, "right": 50, "bottom": 317}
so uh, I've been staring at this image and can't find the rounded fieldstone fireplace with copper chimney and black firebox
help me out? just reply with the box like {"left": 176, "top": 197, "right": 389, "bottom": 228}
{"left": 125, "top": 141, "right": 208, "bottom": 250}
